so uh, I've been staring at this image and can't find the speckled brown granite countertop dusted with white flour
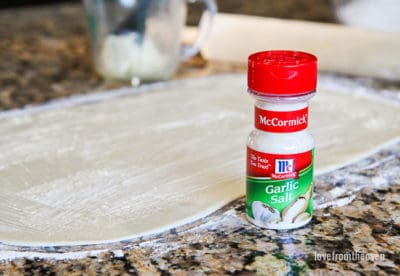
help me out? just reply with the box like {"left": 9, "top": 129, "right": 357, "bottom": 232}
{"left": 0, "top": 1, "right": 400, "bottom": 275}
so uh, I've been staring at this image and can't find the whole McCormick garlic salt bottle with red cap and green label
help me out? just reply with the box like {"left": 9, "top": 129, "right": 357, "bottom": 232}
{"left": 246, "top": 51, "right": 317, "bottom": 229}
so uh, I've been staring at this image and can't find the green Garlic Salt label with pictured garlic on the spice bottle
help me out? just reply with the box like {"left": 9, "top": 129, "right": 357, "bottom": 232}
{"left": 246, "top": 150, "right": 313, "bottom": 229}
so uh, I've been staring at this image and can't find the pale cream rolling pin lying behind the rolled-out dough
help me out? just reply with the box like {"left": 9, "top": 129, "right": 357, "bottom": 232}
{"left": 197, "top": 14, "right": 400, "bottom": 81}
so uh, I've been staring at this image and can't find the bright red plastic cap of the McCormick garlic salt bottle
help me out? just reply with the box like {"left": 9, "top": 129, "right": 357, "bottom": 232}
{"left": 247, "top": 50, "right": 317, "bottom": 96}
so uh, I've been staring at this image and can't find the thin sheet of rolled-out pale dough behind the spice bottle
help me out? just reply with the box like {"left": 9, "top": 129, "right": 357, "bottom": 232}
{"left": 0, "top": 75, "right": 400, "bottom": 246}
